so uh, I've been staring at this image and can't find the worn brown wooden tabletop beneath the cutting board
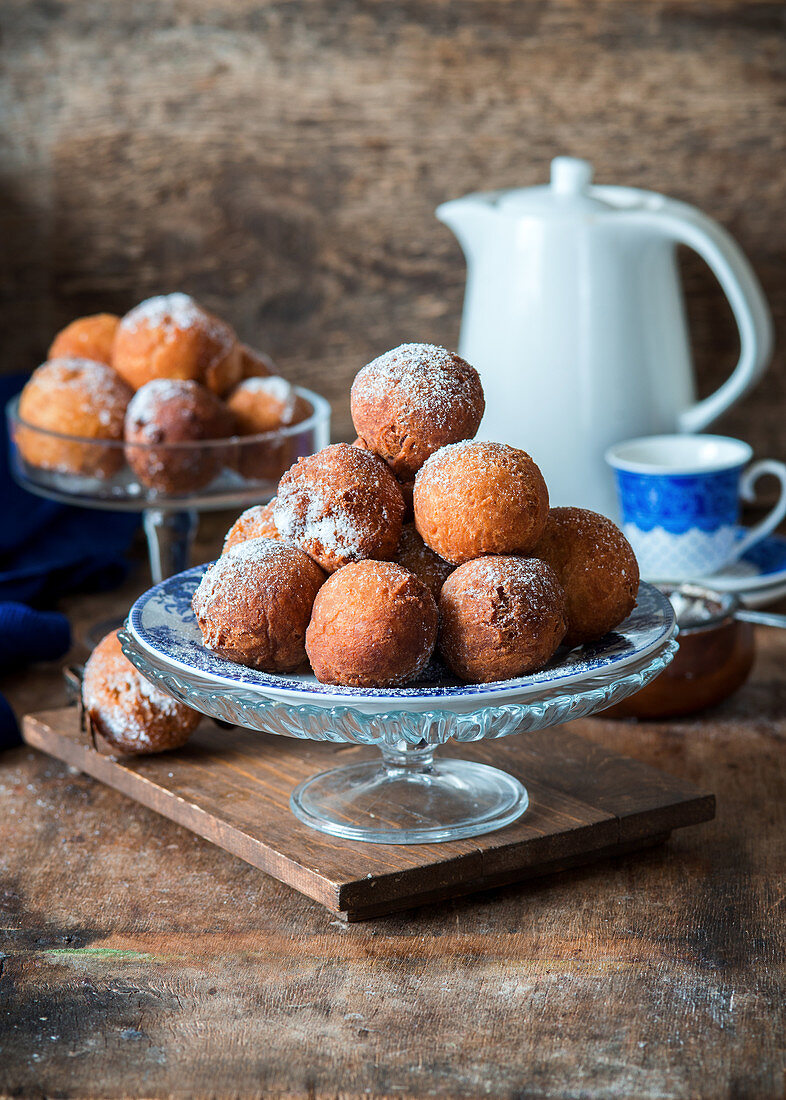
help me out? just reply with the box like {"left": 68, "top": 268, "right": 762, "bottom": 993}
{"left": 0, "top": 528, "right": 786, "bottom": 1100}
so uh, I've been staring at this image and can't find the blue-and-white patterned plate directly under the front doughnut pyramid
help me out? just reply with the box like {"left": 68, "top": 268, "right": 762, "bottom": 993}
{"left": 126, "top": 564, "right": 675, "bottom": 714}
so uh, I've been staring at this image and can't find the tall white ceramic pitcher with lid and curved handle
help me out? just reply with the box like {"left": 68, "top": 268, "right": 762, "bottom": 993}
{"left": 436, "top": 156, "right": 773, "bottom": 516}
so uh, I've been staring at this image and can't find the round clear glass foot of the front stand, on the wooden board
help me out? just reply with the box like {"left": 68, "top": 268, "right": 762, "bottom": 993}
{"left": 289, "top": 744, "right": 529, "bottom": 844}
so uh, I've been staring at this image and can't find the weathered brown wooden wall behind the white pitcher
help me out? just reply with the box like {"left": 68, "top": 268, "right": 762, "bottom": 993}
{"left": 0, "top": 0, "right": 786, "bottom": 448}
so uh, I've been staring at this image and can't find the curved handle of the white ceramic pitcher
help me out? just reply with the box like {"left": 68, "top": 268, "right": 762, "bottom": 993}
{"left": 644, "top": 199, "right": 773, "bottom": 432}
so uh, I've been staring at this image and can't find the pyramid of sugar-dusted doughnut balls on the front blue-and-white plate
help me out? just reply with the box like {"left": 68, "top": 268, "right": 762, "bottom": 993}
{"left": 193, "top": 344, "right": 639, "bottom": 688}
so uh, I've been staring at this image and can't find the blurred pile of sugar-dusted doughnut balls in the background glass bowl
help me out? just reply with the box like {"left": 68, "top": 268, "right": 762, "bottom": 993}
{"left": 16, "top": 294, "right": 312, "bottom": 494}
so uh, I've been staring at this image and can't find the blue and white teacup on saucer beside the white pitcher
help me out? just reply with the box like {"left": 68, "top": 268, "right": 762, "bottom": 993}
{"left": 606, "top": 436, "right": 786, "bottom": 581}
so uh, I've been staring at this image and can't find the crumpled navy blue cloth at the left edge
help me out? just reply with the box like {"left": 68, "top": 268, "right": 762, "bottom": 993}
{"left": 0, "top": 374, "right": 139, "bottom": 749}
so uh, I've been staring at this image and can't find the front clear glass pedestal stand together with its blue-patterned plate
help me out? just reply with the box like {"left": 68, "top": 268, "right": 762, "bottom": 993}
{"left": 120, "top": 565, "right": 677, "bottom": 844}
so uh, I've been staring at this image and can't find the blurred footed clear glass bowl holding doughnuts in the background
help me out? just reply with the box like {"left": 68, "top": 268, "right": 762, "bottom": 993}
{"left": 5, "top": 386, "right": 330, "bottom": 585}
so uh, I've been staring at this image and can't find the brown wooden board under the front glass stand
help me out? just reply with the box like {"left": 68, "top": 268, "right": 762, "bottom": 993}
{"left": 23, "top": 707, "right": 715, "bottom": 921}
